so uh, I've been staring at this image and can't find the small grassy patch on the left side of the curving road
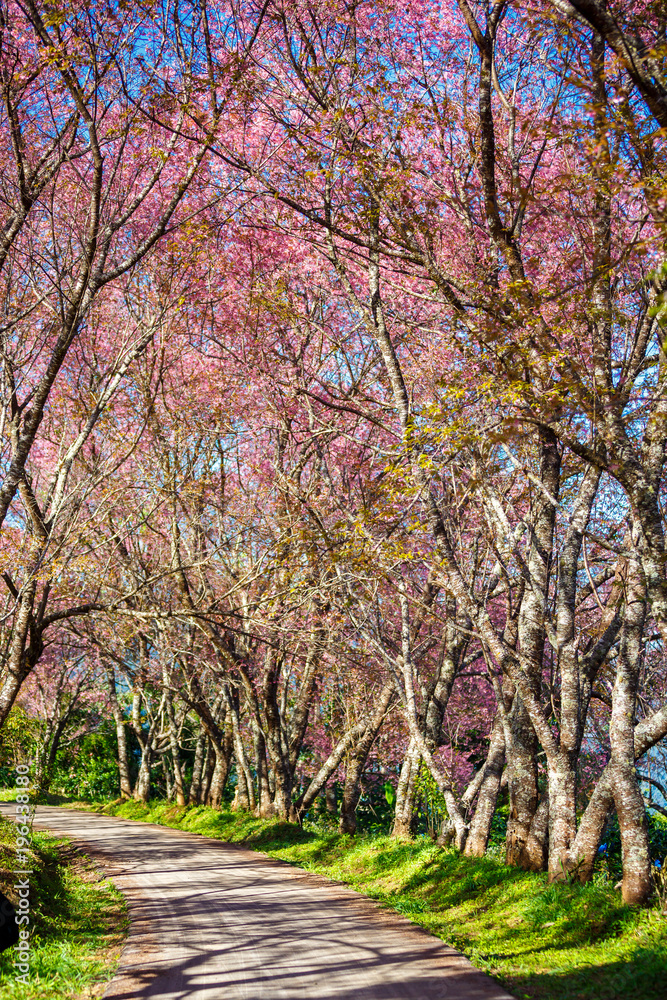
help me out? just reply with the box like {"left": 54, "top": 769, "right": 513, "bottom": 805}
{"left": 0, "top": 818, "right": 127, "bottom": 1000}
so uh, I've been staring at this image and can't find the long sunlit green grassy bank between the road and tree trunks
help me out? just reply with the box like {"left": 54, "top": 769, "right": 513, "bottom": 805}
{"left": 83, "top": 802, "right": 667, "bottom": 1000}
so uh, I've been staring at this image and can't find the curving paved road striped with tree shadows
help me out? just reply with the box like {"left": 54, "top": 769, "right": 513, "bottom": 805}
{"left": 1, "top": 806, "right": 512, "bottom": 1000}
